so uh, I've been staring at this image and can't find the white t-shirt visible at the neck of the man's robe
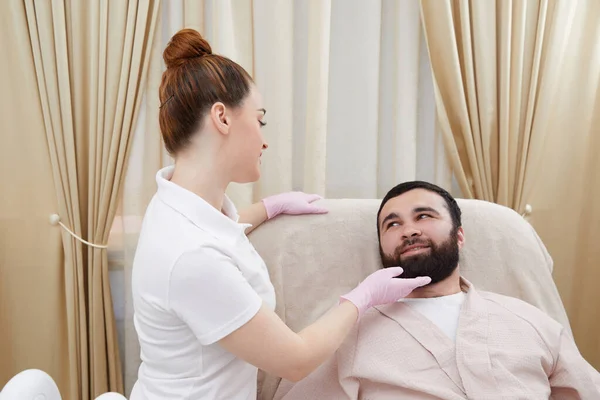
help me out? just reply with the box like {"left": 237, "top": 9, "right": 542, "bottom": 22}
{"left": 401, "top": 292, "right": 465, "bottom": 341}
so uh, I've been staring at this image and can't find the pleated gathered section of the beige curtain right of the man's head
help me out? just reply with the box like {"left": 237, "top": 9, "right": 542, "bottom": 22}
{"left": 421, "top": 0, "right": 573, "bottom": 212}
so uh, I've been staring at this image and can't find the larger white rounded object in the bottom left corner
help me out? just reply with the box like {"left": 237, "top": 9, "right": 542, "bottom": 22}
{"left": 0, "top": 369, "right": 62, "bottom": 400}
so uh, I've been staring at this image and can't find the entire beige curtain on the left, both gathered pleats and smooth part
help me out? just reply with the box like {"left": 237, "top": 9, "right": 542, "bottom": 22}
{"left": 1, "top": 0, "right": 159, "bottom": 400}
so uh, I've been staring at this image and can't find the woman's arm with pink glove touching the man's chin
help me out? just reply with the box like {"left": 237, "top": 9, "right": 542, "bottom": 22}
{"left": 220, "top": 267, "right": 424, "bottom": 381}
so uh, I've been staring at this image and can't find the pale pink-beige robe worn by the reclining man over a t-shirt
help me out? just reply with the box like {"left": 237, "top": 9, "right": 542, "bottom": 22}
{"left": 275, "top": 280, "right": 600, "bottom": 400}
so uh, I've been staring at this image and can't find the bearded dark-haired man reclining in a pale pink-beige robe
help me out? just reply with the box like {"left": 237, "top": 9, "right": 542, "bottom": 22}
{"left": 275, "top": 181, "right": 600, "bottom": 400}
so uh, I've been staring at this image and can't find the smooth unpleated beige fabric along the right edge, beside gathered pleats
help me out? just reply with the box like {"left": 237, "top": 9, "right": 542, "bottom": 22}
{"left": 528, "top": 0, "right": 600, "bottom": 370}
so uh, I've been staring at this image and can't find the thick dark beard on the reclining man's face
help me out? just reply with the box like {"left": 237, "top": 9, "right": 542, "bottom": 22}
{"left": 379, "top": 229, "right": 459, "bottom": 285}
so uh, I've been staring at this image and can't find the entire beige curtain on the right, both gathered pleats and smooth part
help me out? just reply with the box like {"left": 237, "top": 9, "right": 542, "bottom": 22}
{"left": 421, "top": 0, "right": 600, "bottom": 367}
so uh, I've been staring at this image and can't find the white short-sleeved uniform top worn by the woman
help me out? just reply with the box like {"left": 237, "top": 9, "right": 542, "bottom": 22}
{"left": 131, "top": 167, "right": 275, "bottom": 400}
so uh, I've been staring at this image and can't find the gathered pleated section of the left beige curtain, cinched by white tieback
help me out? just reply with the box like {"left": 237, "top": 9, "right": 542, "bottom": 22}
{"left": 20, "top": 0, "right": 160, "bottom": 399}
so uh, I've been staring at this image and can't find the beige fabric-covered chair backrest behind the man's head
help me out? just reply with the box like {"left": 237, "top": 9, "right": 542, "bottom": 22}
{"left": 250, "top": 199, "right": 570, "bottom": 400}
